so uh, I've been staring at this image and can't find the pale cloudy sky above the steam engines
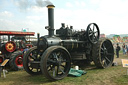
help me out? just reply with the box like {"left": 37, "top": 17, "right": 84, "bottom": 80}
{"left": 0, "top": 0, "right": 128, "bottom": 35}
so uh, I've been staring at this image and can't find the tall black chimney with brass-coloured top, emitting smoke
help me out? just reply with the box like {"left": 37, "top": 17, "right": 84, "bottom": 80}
{"left": 47, "top": 5, "right": 55, "bottom": 37}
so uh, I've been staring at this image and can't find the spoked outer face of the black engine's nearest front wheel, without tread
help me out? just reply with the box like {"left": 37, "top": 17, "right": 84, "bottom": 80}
{"left": 46, "top": 49, "right": 70, "bottom": 79}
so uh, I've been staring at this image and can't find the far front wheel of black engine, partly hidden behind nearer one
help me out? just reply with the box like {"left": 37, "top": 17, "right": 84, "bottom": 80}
{"left": 23, "top": 46, "right": 42, "bottom": 75}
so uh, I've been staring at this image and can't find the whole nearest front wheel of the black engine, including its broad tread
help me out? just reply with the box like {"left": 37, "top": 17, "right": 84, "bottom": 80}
{"left": 40, "top": 46, "right": 71, "bottom": 80}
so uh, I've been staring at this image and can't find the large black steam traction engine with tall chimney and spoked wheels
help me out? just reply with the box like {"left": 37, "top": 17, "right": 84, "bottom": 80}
{"left": 23, "top": 5, "right": 114, "bottom": 80}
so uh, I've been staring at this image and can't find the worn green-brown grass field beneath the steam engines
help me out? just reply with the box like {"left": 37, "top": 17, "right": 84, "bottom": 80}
{"left": 0, "top": 52, "right": 128, "bottom": 85}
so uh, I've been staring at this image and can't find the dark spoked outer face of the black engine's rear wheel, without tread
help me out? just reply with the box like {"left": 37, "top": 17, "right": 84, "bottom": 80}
{"left": 100, "top": 40, "right": 114, "bottom": 67}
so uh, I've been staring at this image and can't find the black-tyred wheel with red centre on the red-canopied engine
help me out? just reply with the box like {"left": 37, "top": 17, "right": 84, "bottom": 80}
{"left": 9, "top": 51, "right": 23, "bottom": 71}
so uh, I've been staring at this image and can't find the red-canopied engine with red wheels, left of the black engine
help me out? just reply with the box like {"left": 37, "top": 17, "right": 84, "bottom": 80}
{"left": 0, "top": 31, "right": 35, "bottom": 70}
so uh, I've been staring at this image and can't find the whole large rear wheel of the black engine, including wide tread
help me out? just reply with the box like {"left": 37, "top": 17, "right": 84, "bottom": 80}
{"left": 92, "top": 38, "right": 114, "bottom": 68}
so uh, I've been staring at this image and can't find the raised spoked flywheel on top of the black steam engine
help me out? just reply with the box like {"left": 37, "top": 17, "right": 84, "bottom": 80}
{"left": 86, "top": 23, "right": 100, "bottom": 44}
